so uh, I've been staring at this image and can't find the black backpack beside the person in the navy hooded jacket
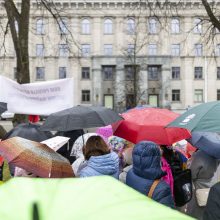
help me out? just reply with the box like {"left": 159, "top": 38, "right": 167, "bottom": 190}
{"left": 164, "top": 149, "right": 192, "bottom": 207}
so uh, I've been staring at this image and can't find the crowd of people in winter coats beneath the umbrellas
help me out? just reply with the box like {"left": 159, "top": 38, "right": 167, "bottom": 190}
{"left": 0, "top": 122, "right": 220, "bottom": 220}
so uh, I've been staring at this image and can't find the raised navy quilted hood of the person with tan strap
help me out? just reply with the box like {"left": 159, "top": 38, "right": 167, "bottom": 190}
{"left": 132, "top": 141, "right": 166, "bottom": 180}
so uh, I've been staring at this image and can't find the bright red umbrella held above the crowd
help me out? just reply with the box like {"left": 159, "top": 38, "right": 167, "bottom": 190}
{"left": 112, "top": 108, "right": 191, "bottom": 145}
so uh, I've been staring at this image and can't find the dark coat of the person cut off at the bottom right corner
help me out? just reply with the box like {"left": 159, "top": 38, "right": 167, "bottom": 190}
{"left": 203, "top": 182, "right": 220, "bottom": 220}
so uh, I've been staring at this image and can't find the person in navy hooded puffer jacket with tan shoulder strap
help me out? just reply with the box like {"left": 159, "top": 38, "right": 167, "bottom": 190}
{"left": 126, "top": 141, "right": 174, "bottom": 208}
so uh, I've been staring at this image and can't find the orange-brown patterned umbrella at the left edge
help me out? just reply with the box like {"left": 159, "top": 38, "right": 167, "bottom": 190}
{"left": 0, "top": 137, "right": 73, "bottom": 178}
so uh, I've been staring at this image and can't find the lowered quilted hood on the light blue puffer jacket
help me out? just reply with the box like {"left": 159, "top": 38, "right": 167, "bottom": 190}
{"left": 87, "top": 152, "right": 119, "bottom": 175}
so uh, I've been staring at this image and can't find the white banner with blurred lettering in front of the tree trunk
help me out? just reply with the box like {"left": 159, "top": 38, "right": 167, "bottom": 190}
{"left": 0, "top": 76, "right": 73, "bottom": 115}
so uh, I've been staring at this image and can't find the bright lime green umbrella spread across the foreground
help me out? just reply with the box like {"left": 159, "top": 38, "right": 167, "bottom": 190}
{"left": 0, "top": 176, "right": 191, "bottom": 220}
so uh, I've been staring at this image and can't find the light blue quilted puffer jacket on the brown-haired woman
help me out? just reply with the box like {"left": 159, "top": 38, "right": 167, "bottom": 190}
{"left": 79, "top": 152, "right": 119, "bottom": 179}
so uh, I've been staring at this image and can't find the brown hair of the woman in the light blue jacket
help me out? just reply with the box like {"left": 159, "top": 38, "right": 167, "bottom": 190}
{"left": 83, "top": 136, "right": 110, "bottom": 160}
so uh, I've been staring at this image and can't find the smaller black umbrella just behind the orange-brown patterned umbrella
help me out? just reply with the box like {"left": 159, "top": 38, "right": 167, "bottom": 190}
{"left": 3, "top": 123, "right": 53, "bottom": 142}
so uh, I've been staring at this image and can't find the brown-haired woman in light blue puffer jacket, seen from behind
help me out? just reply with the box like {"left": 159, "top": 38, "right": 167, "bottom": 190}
{"left": 79, "top": 136, "right": 119, "bottom": 179}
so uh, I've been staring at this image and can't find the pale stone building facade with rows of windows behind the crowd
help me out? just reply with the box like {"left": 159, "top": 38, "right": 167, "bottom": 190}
{"left": 0, "top": 0, "right": 220, "bottom": 112}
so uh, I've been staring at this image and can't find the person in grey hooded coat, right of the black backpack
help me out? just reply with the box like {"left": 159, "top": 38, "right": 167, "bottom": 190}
{"left": 186, "top": 150, "right": 218, "bottom": 219}
